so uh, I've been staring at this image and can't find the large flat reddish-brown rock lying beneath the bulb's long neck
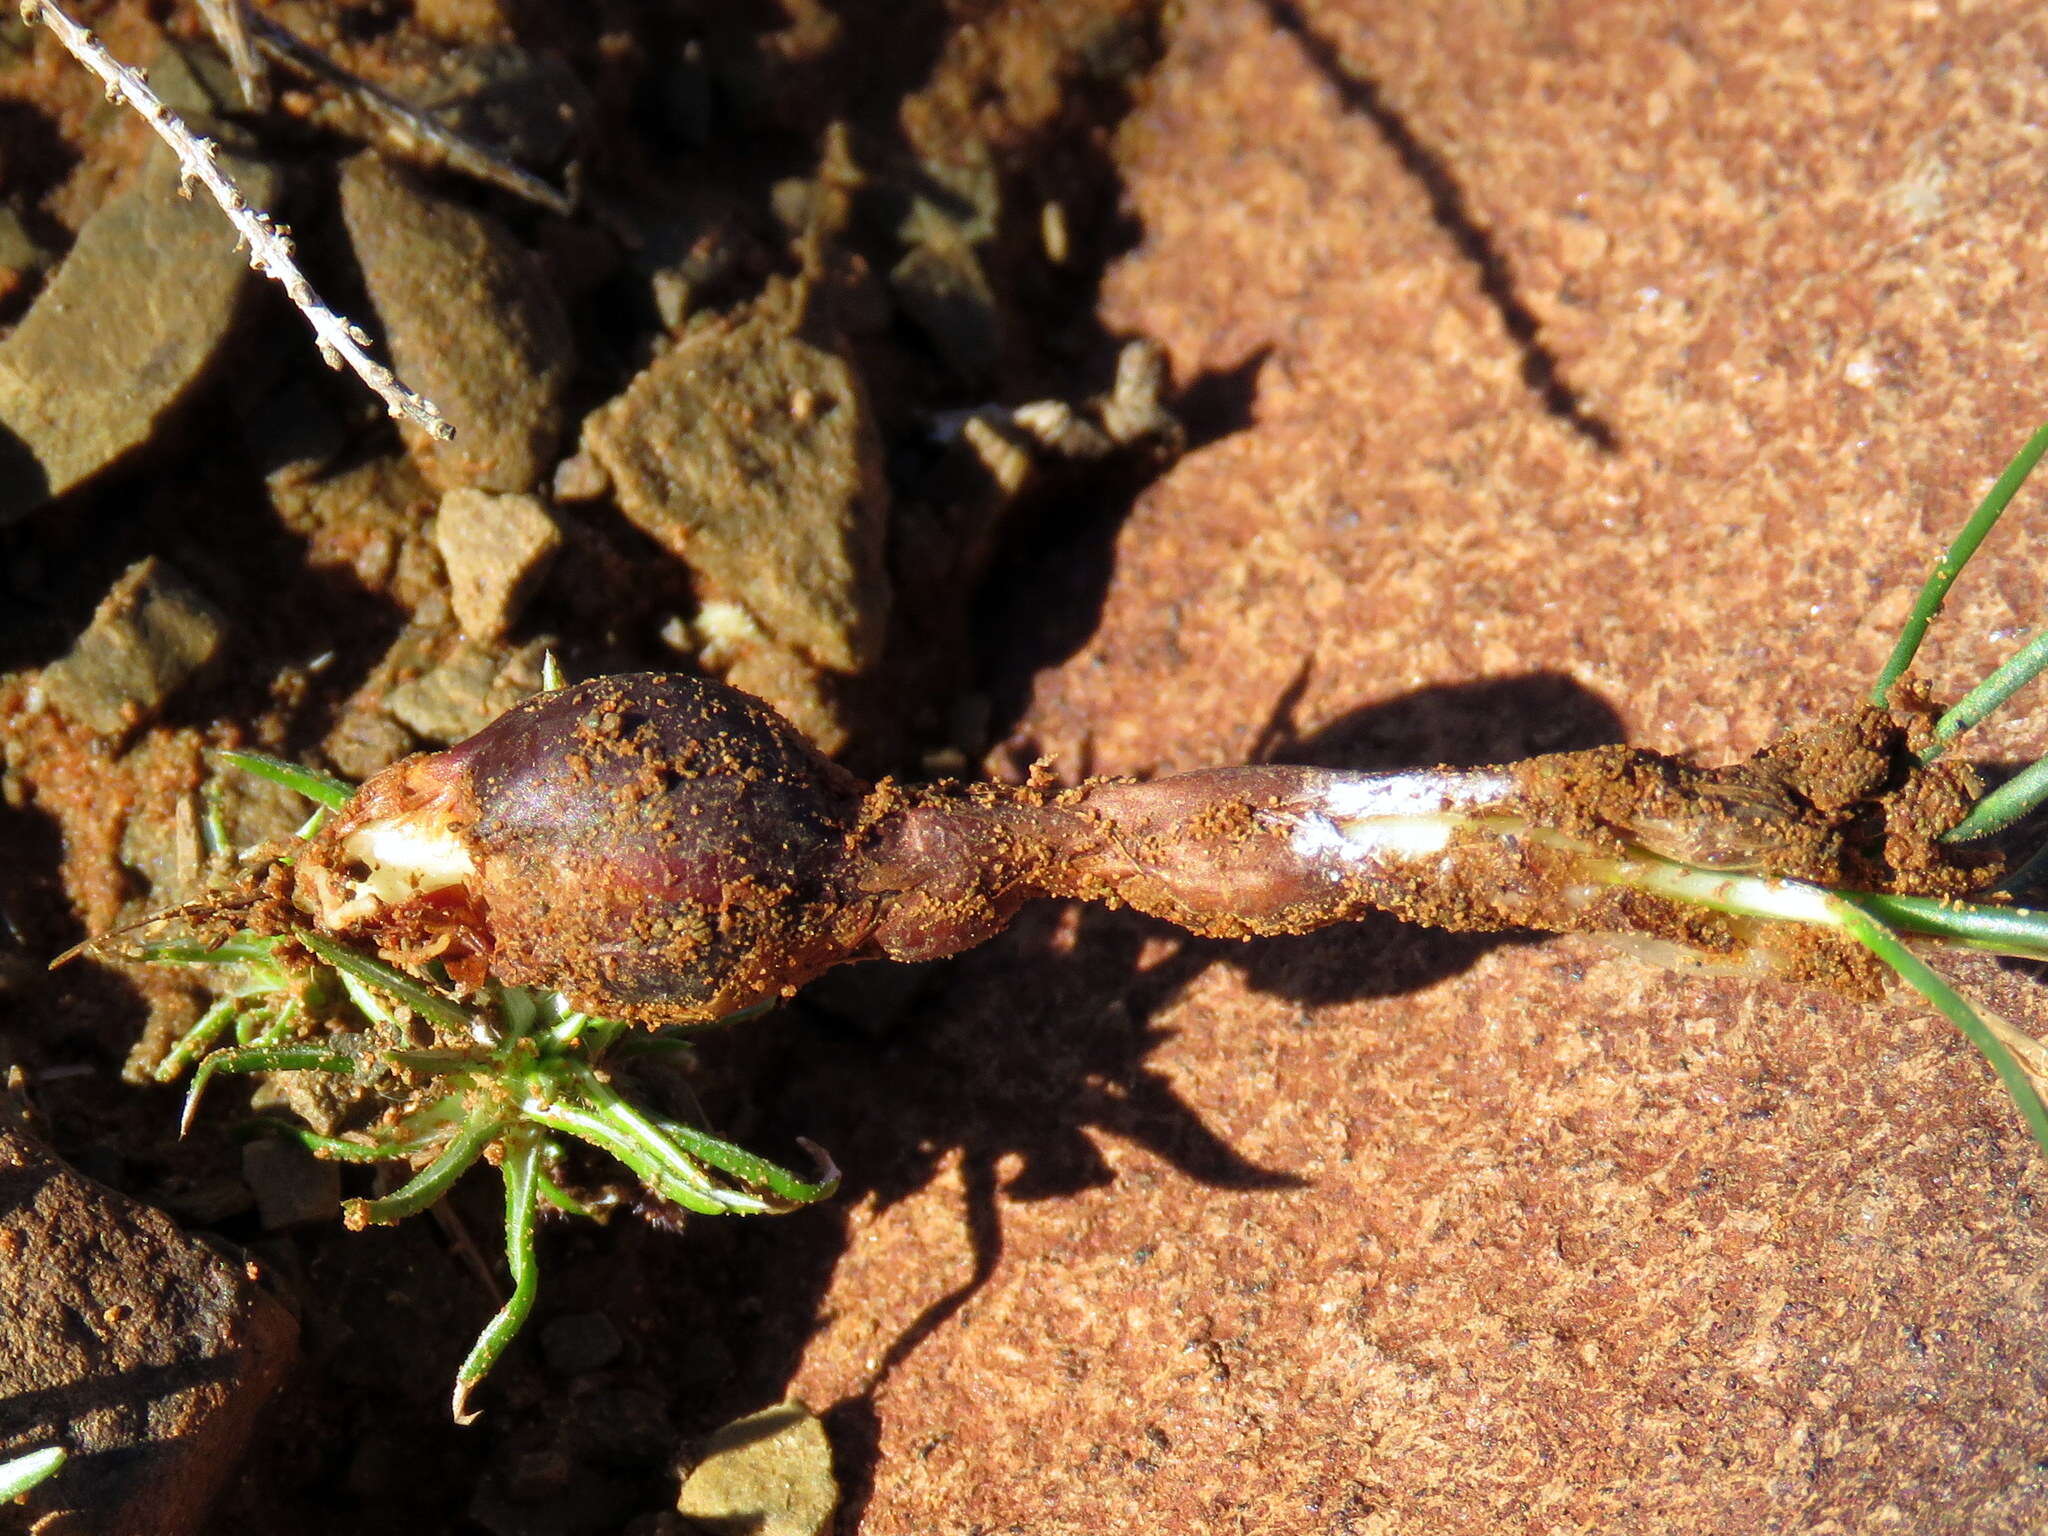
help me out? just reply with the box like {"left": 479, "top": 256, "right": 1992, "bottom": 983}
{"left": 791, "top": 0, "right": 2048, "bottom": 1536}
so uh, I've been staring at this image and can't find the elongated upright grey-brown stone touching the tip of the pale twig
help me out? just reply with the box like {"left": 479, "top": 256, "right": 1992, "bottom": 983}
{"left": 342, "top": 154, "right": 571, "bottom": 492}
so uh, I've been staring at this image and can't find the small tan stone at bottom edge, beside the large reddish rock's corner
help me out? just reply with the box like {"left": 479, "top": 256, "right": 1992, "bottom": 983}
{"left": 676, "top": 1401, "right": 840, "bottom": 1536}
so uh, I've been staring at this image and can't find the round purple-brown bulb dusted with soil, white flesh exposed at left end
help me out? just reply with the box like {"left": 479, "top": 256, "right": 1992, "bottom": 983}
{"left": 297, "top": 674, "right": 874, "bottom": 1022}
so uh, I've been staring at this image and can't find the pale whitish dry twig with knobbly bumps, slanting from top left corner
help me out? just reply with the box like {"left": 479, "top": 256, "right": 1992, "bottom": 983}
{"left": 20, "top": 0, "right": 455, "bottom": 440}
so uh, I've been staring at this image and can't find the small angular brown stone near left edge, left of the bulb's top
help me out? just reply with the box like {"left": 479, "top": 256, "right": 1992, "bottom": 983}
{"left": 43, "top": 555, "right": 227, "bottom": 735}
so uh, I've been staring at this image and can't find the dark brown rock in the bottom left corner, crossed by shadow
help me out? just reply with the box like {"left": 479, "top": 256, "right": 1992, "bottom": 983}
{"left": 0, "top": 1096, "right": 297, "bottom": 1536}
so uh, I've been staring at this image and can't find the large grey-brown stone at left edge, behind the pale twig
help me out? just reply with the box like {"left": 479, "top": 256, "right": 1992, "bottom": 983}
{"left": 0, "top": 147, "right": 279, "bottom": 522}
